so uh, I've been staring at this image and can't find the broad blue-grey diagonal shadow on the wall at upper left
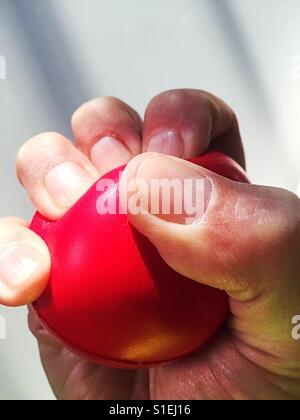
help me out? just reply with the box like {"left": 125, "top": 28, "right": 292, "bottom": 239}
{"left": 2, "top": 0, "right": 93, "bottom": 132}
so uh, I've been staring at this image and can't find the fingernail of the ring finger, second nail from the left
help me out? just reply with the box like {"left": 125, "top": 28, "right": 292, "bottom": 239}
{"left": 44, "top": 162, "right": 93, "bottom": 208}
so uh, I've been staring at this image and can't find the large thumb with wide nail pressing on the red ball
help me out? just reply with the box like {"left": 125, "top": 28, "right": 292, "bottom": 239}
{"left": 120, "top": 154, "right": 300, "bottom": 301}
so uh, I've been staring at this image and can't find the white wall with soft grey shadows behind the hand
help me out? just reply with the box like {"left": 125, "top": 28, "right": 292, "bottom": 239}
{"left": 0, "top": 0, "right": 300, "bottom": 399}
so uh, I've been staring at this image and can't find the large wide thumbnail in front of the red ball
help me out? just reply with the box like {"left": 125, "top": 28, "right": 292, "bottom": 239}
{"left": 129, "top": 155, "right": 212, "bottom": 225}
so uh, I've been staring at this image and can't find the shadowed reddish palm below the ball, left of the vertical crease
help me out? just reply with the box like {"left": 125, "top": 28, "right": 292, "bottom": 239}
{"left": 29, "top": 311, "right": 148, "bottom": 400}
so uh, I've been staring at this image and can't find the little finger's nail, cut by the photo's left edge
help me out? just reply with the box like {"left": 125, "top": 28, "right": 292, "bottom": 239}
{"left": 0, "top": 244, "right": 43, "bottom": 289}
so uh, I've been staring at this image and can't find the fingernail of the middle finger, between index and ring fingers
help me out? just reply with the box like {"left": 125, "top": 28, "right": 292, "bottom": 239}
{"left": 91, "top": 137, "right": 132, "bottom": 173}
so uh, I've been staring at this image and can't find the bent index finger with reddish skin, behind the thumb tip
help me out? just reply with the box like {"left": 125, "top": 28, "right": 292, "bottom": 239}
{"left": 143, "top": 89, "right": 245, "bottom": 166}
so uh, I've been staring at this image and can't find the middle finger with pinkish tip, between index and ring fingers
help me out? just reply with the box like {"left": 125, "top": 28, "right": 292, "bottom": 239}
{"left": 72, "top": 97, "right": 142, "bottom": 175}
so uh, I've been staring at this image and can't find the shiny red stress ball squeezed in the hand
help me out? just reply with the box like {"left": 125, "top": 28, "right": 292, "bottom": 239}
{"left": 31, "top": 152, "right": 247, "bottom": 369}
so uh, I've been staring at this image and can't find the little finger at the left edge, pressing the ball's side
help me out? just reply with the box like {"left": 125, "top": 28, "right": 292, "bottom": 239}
{"left": 0, "top": 218, "right": 50, "bottom": 306}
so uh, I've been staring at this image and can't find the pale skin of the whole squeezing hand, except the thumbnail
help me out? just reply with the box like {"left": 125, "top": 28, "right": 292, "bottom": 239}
{"left": 0, "top": 90, "right": 300, "bottom": 400}
